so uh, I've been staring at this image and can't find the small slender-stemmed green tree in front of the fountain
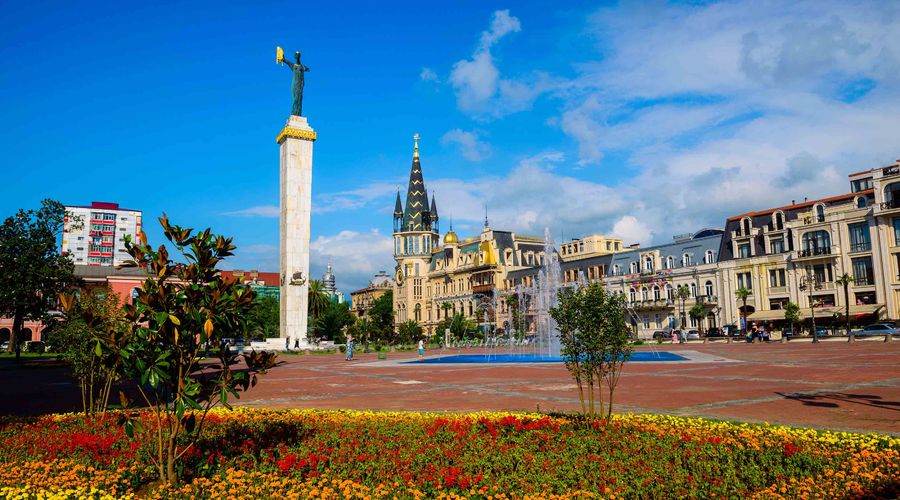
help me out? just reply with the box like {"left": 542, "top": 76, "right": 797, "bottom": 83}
{"left": 550, "top": 283, "right": 632, "bottom": 416}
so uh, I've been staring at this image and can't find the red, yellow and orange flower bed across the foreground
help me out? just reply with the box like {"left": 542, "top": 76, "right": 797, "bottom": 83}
{"left": 0, "top": 409, "right": 900, "bottom": 498}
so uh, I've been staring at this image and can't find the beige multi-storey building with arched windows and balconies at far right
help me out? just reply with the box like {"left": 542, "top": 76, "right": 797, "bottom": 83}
{"left": 719, "top": 167, "right": 900, "bottom": 330}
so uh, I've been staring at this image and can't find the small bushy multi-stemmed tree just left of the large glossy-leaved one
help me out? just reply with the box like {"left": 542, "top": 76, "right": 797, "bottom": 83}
{"left": 49, "top": 287, "right": 128, "bottom": 415}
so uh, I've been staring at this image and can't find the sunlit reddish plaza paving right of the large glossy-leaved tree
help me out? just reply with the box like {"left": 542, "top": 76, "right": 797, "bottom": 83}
{"left": 239, "top": 339, "right": 900, "bottom": 434}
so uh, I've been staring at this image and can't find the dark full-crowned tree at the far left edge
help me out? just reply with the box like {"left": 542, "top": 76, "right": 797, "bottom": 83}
{"left": 0, "top": 200, "right": 78, "bottom": 355}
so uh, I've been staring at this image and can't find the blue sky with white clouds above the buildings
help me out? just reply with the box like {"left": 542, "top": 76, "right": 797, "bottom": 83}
{"left": 0, "top": 2, "right": 900, "bottom": 291}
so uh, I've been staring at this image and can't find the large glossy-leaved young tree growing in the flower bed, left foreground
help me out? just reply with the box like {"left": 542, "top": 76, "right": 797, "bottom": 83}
{"left": 121, "top": 215, "right": 275, "bottom": 484}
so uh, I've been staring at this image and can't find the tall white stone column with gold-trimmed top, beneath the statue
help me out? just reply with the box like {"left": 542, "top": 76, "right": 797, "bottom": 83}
{"left": 277, "top": 115, "right": 316, "bottom": 348}
